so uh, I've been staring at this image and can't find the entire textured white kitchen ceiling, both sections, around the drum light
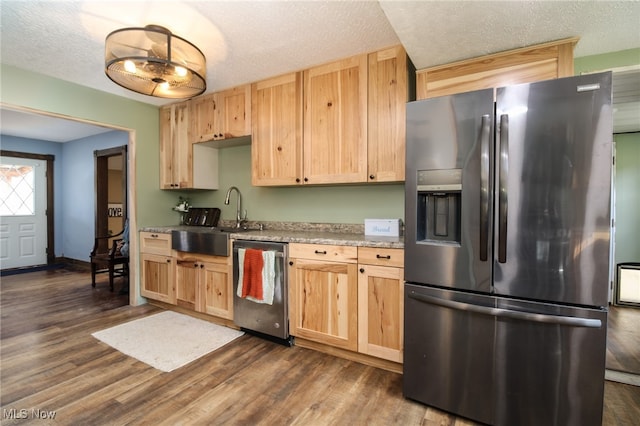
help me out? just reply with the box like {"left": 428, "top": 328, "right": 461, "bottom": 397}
{"left": 0, "top": 0, "right": 640, "bottom": 141}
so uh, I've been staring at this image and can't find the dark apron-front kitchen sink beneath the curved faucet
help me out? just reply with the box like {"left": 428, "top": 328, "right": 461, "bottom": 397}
{"left": 171, "top": 227, "right": 246, "bottom": 256}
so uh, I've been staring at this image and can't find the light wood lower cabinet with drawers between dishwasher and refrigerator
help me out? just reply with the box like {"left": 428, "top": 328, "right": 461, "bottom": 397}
{"left": 289, "top": 243, "right": 404, "bottom": 363}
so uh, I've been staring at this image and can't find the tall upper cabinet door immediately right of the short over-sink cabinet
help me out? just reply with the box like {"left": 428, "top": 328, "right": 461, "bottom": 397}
{"left": 251, "top": 73, "right": 303, "bottom": 186}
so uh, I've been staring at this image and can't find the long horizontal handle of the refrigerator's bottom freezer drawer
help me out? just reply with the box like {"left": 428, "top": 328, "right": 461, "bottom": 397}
{"left": 408, "top": 291, "right": 602, "bottom": 328}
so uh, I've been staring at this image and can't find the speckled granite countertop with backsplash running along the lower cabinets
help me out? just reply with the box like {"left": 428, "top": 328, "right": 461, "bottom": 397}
{"left": 140, "top": 222, "right": 404, "bottom": 249}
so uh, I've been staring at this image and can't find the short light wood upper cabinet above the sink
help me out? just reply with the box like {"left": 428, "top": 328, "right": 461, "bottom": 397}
{"left": 190, "top": 84, "right": 251, "bottom": 142}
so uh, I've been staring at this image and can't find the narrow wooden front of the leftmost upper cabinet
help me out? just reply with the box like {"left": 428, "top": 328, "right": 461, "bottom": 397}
{"left": 160, "top": 102, "right": 193, "bottom": 189}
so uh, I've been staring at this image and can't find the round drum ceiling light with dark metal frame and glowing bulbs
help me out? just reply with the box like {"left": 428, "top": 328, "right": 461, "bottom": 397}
{"left": 105, "top": 25, "right": 207, "bottom": 99}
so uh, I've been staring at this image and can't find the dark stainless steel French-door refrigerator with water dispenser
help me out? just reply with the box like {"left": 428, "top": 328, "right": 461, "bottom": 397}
{"left": 403, "top": 73, "right": 612, "bottom": 426}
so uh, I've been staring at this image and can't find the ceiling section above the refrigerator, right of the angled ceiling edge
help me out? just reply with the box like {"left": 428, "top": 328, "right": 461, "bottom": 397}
{"left": 380, "top": 0, "right": 640, "bottom": 69}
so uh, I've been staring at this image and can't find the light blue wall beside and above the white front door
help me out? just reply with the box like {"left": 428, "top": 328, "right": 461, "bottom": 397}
{"left": 0, "top": 131, "right": 129, "bottom": 262}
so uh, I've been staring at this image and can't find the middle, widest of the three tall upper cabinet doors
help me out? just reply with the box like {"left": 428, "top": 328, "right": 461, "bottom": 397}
{"left": 303, "top": 54, "right": 367, "bottom": 184}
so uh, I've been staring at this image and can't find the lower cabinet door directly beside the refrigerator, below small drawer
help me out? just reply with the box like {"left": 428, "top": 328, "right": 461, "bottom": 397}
{"left": 358, "top": 265, "right": 404, "bottom": 362}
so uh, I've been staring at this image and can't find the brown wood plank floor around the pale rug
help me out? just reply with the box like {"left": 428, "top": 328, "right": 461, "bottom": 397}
{"left": 0, "top": 269, "right": 640, "bottom": 426}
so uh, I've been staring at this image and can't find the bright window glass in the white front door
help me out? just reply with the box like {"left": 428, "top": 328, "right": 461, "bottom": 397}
{"left": 0, "top": 164, "right": 35, "bottom": 216}
